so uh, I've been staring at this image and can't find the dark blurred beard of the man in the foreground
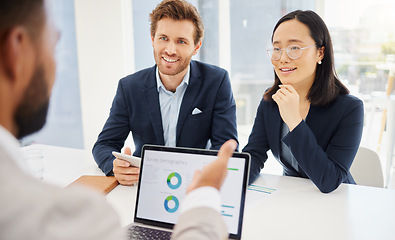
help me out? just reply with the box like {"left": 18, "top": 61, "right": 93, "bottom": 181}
{"left": 14, "top": 65, "right": 49, "bottom": 139}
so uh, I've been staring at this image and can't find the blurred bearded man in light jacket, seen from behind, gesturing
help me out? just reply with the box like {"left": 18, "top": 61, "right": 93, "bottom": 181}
{"left": 0, "top": 0, "right": 237, "bottom": 239}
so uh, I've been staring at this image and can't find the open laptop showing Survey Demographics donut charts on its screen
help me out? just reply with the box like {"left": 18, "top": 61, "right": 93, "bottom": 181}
{"left": 129, "top": 145, "right": 250, "bottom": 239}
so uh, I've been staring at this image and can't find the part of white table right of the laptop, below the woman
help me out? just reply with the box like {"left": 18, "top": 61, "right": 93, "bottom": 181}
{"left": 243, "top": 175, "right": 395, "bottom": 239}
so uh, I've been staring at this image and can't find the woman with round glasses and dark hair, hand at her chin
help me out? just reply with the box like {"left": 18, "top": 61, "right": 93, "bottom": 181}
{"left": 243, "top": 10, "right": 364, "bottom": 193}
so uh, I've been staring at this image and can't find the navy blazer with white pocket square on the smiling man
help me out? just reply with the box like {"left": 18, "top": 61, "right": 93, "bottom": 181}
{"left": 92, "top": 61, "right": 237, "bottom": 175}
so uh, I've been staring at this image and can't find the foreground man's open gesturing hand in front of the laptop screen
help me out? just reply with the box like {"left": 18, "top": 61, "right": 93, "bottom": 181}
{"left": 187, "top": 139, "right": 237, "bottom": 193}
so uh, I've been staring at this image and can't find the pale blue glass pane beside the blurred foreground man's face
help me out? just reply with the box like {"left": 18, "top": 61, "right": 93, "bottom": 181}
{"left": 22, "top": 0, "right": 84, "bottom": 149}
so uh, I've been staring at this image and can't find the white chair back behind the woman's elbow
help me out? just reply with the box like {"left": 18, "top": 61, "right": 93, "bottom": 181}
{"left": 350, "top": 147, "right": 384, "bottom": 188}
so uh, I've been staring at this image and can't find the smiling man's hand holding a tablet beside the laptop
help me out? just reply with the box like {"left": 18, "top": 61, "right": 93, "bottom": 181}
{"left": 112, "top": 147, "right": 140, "bottom": 185}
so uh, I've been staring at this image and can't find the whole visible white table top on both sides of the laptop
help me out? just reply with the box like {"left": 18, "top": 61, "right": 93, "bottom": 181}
{"left": 23, "top": 145, "right": 395, "bottom": 240}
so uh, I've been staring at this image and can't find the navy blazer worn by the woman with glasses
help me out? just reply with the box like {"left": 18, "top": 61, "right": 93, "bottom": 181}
{"left": 243, "top": 94, "right": 364, "bottom": 193}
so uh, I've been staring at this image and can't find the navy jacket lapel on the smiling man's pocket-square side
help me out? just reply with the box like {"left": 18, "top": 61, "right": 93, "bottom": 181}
{"left": 176, "top": 61, "right": 202, "bottom": 145}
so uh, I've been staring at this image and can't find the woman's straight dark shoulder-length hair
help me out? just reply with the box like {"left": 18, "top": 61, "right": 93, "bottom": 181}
{"left": 264, "top": 10, "right": 349, "bottom": 106}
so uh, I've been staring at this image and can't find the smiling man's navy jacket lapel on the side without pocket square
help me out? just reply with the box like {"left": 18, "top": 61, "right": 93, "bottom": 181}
{"left": 143, "top": 66, "right": 165, "bottom": 145}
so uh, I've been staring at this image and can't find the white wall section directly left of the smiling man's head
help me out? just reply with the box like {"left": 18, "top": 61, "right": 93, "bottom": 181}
{"left": 74, "top": 0, "right": 134, "bottom": 151}
